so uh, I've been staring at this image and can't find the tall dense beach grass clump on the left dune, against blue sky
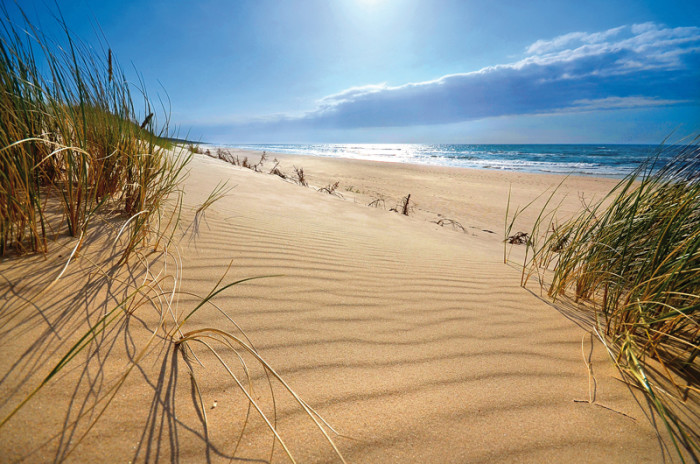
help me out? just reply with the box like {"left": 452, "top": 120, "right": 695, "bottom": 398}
{"left": 0, "top": 6, "right": 187, "bottom": 260}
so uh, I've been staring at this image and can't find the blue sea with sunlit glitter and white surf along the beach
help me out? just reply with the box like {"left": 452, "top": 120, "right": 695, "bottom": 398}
{"left": 217, "top": 143, "right": 680, "bottom": 178}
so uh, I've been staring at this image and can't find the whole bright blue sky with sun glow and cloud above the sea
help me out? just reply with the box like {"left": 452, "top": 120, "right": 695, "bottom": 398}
{"left": 9, "top": 0, "right": 700, "bottom": 143}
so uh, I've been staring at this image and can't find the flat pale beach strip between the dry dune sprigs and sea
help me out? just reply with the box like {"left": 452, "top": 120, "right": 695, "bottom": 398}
{"left": 205, "top": 147, "right": 619, "bottom": 239}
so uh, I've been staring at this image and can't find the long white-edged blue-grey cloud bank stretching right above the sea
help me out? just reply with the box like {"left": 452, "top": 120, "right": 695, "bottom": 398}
{"left": 215, "top": 23, "right": 700, "bottom": 133}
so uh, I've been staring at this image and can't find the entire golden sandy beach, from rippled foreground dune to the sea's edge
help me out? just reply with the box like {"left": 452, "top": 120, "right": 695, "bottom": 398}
{"left": 0, "top": 150, "right": 688, "bottom": 463}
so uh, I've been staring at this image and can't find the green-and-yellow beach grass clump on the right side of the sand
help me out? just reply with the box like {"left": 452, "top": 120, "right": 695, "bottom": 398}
{"left": 525, "top": 139, "right": 700, "bottom": 460}
